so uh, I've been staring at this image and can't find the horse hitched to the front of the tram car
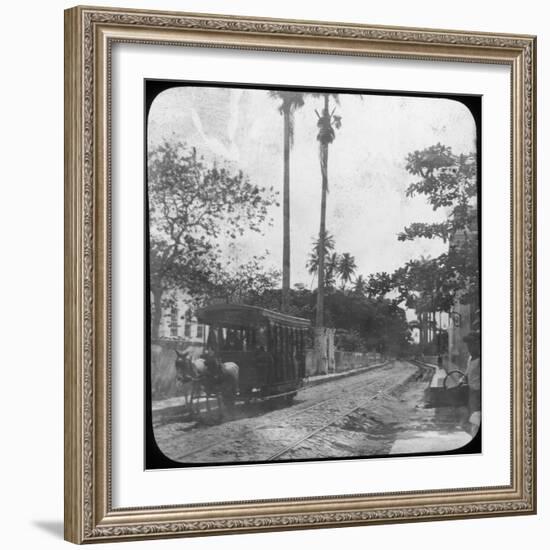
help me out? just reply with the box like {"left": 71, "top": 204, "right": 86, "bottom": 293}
{"left": 175, "top": 351, "right": 239, "bottom": 417}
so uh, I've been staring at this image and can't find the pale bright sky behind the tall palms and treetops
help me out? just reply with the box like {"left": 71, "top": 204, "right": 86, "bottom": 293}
{"left": 148, "top": 87, "right": 476, "bottom": 287}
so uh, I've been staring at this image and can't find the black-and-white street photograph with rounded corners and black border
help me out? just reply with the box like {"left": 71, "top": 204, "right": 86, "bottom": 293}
{"left": 144, "top": 80, "right": 482, "bottom": 469}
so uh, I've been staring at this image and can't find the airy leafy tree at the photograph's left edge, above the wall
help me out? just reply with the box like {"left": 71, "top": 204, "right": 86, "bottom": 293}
{"left": 147, "top": 141, "right": 276, "bottom": 338}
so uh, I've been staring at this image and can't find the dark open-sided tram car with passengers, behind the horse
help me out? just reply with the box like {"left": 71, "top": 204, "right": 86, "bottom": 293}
{"left": 197, "top": 304, "right": 311, "bottom": 401}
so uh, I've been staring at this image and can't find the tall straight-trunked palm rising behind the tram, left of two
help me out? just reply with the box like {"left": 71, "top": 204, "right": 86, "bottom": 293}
{"left": 269, "top": 90, "right": 304, "bottom": 311}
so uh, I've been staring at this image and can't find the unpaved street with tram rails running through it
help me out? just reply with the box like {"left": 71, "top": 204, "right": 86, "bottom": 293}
{"left": 153, "top": 361, "right": 472, "bottom": 464}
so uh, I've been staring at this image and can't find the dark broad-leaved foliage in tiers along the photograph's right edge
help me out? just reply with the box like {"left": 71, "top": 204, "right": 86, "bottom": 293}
{"left": 392, "top": 143, "right": 479, "bottom": 311}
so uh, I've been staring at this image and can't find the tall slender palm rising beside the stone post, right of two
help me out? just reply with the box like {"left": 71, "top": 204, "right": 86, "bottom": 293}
{"left": 312, "top": 93, "right": 342, "bottom": 327}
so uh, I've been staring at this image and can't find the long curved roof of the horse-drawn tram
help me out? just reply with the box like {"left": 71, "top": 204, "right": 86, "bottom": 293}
{"left": 197, "top": 304, "right": 311, "bottom": 329}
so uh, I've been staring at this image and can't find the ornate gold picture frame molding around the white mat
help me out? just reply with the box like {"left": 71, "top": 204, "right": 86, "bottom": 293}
{"left": 64, "top": 7, "right": 536, "bottom": 543}
